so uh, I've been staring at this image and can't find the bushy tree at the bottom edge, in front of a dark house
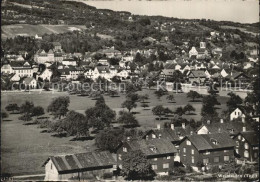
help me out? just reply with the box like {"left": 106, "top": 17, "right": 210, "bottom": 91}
{"left": 122, "top": 150, "right": 155, "bottom": 180}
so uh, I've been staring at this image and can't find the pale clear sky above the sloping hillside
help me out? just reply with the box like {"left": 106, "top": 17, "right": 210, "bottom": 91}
{"left": 79, "top": 0, "right": 259, "bottom": 23}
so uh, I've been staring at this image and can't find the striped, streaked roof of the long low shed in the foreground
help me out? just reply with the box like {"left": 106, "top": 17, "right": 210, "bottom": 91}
{"left": 44, "top": 151, "right": 116, "bottom": 174}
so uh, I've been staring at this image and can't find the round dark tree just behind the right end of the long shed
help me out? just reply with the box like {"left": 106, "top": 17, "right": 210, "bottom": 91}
{"left": 95, "top": 129, "right": 124, "bottom": 152}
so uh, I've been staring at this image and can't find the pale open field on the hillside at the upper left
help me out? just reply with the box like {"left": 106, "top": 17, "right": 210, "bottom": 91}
{"left": 1, "top": 24, "right": 86, "bottom": 39}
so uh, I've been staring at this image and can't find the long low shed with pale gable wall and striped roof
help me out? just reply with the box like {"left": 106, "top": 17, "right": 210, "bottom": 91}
{"left": 43, "top": 151, "right": 116, "bottom": 181}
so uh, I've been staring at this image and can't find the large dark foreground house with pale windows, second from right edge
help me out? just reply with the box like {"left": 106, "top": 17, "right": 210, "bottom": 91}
{"left": 179, "top": 133, "right": 236, "bottom": 167}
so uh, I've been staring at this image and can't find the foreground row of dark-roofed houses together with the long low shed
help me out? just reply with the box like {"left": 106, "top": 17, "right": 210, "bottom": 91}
{"left": 43, "top": 111, "right": 259, "bottom": 180}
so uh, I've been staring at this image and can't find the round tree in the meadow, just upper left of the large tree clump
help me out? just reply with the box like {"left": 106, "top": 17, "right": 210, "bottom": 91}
{"left": 47, "top": 96, "right": 70, "bottom": 119}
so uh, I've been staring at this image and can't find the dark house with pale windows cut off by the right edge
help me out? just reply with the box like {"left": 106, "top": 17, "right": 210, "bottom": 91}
{"left": 233, "top": 131, "right": 259, "bottom": 162}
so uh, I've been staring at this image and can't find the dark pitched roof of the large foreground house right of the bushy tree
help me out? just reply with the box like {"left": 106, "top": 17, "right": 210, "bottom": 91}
{"left": 186, "top": 133, "right": 236, "bottom": 151}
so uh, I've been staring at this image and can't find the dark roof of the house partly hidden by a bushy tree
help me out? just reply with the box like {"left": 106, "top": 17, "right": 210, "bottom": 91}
{"left": 126, "top": 138, "right": 177, "bottom": 156}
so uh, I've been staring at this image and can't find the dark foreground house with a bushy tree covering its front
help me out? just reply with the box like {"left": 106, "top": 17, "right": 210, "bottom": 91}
{"left": 116, "top": 138, "right": 177, "bottom": 174}
